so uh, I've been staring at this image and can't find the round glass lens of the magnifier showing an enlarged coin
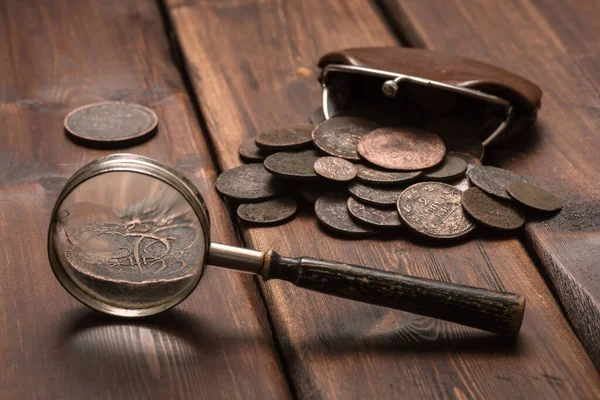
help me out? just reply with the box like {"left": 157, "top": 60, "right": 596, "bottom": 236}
{"left": 51, "top": 172, "right": 206, "bottom": 310}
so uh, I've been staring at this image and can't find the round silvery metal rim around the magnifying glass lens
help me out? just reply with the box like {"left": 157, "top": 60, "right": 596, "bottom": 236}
{"left": 48, "top": 153, "right": 210, "bottom": 318}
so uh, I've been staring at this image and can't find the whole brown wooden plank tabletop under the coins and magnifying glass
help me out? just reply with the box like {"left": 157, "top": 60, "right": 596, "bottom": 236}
{"left": 0, "top": 0, "right": 600, "bottom": 399}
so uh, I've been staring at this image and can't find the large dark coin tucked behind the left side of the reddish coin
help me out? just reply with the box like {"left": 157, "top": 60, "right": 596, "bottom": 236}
{"left": 312, "top": 117, "right": 377, "bottom": 161}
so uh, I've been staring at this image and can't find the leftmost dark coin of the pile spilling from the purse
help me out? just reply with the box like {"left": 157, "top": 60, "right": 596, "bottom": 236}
{"left": 215, "top": 164, "right": 284, "bottom": 201}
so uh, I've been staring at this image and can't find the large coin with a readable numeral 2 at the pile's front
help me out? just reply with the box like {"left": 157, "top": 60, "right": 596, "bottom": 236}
{"left": 398, "top": 182, "right": 475, "bottom": 239}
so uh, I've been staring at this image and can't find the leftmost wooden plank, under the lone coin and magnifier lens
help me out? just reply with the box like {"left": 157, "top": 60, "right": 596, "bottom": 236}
{"left": 0, "top": 0, "right": 289, "bottom": 399}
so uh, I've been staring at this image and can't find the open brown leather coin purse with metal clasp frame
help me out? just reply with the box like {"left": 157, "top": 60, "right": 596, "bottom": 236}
{"left": 319, "top": 47, "right": 542, "bottom": 146}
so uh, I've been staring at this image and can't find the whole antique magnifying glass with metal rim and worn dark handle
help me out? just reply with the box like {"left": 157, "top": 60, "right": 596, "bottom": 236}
{"left": 48, "top": 154, "right": 525, "bottom": 336}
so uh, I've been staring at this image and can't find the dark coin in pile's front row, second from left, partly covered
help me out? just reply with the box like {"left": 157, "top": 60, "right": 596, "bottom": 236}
{"left": 315, "top": 192, "right": 376, "bottom": 235}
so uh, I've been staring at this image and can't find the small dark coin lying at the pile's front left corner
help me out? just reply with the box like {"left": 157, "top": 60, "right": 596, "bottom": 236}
{"left": 237, "top": 197, "right": 298, "bottom": 225}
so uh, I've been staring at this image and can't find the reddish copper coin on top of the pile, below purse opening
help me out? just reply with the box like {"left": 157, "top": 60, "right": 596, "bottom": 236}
{"left": 358, "top": 128, "right": 446, "bottom": 171}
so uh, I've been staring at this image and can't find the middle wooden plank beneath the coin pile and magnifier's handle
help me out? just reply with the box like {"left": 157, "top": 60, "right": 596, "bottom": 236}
{"left": 166, "top": 0, "right": 600, "bottom": 398}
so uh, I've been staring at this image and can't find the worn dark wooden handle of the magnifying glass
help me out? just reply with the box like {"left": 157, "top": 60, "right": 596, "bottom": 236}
{"left": 263, "top": 252, "right": 525, "bottom": 336}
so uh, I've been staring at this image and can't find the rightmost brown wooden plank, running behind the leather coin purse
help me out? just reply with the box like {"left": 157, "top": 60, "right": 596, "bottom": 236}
{"left": 386, "top": 0, "right": 600, "bottom": 368}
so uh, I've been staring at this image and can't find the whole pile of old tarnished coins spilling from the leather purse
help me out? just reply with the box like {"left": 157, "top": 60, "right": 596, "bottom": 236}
{"left": 216, "top": 109, "right": 560, "bottom": 239}
